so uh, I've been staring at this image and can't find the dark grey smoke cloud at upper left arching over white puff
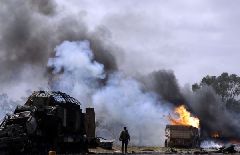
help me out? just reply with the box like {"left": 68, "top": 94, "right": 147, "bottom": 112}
{"left": 0, "top": 0, "right": 118, "bottom": 98}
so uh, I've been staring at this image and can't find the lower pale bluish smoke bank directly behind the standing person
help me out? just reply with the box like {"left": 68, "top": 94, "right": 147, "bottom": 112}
{"left": 93, "top": 73, "right": 171, "bottom": 145}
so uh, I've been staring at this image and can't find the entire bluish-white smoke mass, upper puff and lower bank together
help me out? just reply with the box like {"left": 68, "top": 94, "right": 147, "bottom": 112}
{"left": 48, "top": 41, "right": 169, "bottom": 145}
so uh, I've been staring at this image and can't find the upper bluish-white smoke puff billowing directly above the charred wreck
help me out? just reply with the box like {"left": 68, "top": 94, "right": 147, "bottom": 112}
{"left": 48, "top": 41, "right": 105, "bottom": 103}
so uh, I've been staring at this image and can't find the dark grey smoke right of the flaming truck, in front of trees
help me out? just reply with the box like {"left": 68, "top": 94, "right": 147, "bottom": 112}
{"left": 185, "top": 87, "right": 240, "bottom": 138}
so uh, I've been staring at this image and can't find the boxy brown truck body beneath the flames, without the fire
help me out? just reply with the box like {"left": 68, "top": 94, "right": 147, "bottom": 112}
{"left": 165, "top": 125, "right": 200, "bottom": 148}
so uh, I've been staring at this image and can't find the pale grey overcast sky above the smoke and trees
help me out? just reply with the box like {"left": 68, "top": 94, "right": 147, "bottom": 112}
{"left": 56, "top": 0, "right": 240, "bottom": 85}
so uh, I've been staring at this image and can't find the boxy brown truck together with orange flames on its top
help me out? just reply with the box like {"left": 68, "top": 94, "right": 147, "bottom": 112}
{"left": 165, "top": 105, "right": 200, "bottom": 148}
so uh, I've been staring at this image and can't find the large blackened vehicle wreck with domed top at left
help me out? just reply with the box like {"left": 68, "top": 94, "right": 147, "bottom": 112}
{"left": 0, "top": 91, "right": 95, "bottom": 154}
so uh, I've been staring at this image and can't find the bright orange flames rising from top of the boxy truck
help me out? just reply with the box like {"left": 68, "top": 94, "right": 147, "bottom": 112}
{"left": 169, "top": 105, "right": 199, "bottom": 128}
